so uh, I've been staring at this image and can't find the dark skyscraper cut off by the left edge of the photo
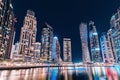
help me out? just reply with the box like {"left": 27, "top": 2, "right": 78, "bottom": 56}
{"left": 0, "top": 0, "right": 15, "bottom": 59}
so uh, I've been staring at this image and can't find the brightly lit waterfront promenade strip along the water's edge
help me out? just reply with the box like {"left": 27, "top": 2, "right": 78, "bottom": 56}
{"left": 0, "top": 64, "right": 116, "bottom": 70}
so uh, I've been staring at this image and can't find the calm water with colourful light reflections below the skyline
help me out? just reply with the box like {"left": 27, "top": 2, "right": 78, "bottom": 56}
{"left": 0, "top": 67, "right": 120, "bottom": 80}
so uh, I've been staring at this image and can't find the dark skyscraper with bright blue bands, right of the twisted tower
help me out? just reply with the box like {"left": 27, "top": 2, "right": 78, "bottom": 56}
{"left": 89, "top": 21, "right": 102, "bottom": 62}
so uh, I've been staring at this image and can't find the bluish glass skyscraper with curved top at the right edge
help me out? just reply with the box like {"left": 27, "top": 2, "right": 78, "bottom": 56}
{"left": 110, "top": 9, "right": 120, "bottom": 63}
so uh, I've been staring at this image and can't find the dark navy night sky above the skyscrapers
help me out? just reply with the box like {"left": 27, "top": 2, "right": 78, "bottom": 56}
{"left": 12, "top": 0, "right": 120, "bottom": 62}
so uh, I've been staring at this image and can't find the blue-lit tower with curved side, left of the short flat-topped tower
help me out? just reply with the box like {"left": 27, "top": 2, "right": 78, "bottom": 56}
{"left": 52, "top": 37, "right": 62, "bottom": 62}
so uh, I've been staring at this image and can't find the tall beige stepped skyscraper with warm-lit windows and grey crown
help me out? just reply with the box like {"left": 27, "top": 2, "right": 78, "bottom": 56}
{"left": 19, "top": 10, "right": 37, "bottom": 60}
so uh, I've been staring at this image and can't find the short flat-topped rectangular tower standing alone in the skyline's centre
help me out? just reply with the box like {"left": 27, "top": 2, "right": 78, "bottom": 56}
{"left": 63, "top": 38, "right": 72, "bottom": 62}
